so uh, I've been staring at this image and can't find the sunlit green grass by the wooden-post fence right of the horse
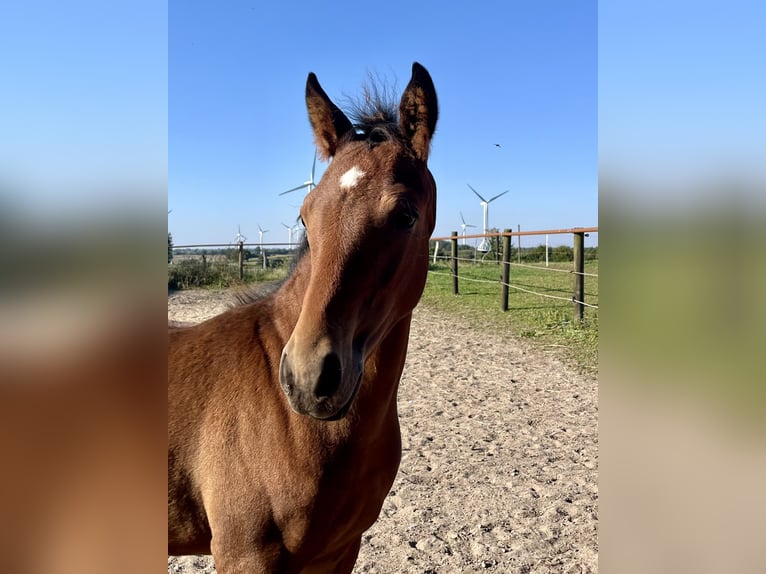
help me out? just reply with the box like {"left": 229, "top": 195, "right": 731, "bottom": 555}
{"left": 421, "top": 261, "right": 598, "bottom": 372}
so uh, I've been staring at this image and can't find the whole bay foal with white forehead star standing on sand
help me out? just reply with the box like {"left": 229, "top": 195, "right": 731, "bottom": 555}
{"left": 168, "top": 62, "right": 438, "bottom": 574}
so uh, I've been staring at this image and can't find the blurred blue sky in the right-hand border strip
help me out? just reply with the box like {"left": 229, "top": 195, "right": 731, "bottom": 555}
{"left": 598, "top": 0, "right": 766, "bottom": 202}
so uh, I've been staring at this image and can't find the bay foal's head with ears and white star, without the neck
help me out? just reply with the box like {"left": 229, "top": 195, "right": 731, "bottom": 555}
{"left": 279, "top": 63, "right": 437, "bottom": 420}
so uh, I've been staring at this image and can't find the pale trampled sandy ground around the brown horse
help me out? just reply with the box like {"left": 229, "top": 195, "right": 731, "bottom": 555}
{"left": 168, "top": 291, "right": 598, "bottom": 574}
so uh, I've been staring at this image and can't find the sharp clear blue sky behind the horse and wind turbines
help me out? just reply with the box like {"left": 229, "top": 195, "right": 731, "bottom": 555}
{"left": 168, "top": 0, "right": 598, "bottom": 245}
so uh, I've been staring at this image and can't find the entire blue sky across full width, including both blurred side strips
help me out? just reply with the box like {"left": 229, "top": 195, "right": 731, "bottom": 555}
{"left": 0, "top": 0, "right": 766, "bottom": 250}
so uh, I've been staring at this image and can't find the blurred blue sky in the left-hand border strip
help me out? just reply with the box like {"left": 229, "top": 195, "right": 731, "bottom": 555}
{"left": 0, "top": 0, "right": 168, "bottom": 215}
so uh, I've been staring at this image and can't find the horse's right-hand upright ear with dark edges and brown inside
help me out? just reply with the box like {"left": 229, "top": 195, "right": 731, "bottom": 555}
{"left": 399, "top": 62, "right": 439, "bottom": 161}
